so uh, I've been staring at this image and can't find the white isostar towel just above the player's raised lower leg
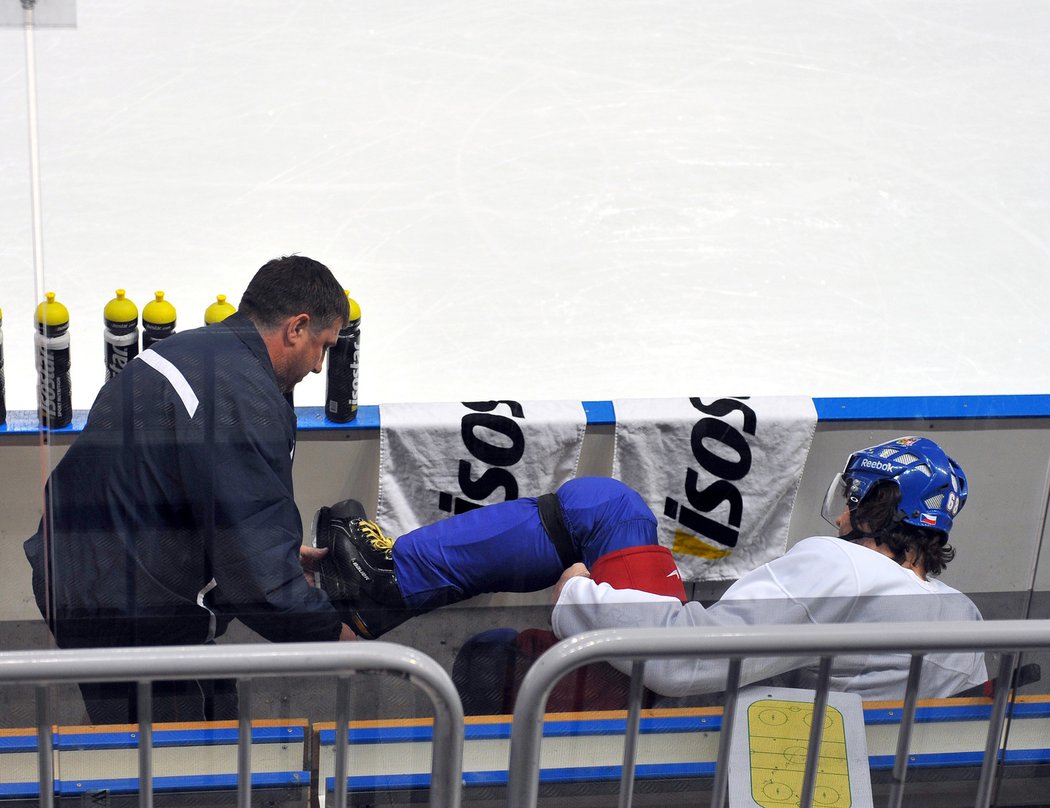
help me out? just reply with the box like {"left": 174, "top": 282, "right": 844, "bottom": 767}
{"left": 376, "top": 401, "right": 587, "bottom": 536}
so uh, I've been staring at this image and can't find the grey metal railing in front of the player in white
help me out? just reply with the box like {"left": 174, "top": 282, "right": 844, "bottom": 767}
{"left": 507, "top": 620, "right": 1050, "bottom": 808}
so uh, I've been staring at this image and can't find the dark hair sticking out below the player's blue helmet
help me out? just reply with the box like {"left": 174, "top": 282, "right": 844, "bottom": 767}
{"left": 853, "top": 480, "right": 956, "bottom": 576}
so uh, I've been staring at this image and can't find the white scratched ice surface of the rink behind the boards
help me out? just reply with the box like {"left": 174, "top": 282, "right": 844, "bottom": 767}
{"left": 0, "top": 0, "right": 1050, "bottom": 409}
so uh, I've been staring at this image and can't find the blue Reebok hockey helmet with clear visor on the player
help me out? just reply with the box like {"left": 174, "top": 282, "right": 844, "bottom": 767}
{"left": 822, "top": 435, "right": 967, "bottom": 541}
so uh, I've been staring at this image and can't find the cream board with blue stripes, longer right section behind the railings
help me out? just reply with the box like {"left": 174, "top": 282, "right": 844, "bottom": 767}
{"left": 313, "top": 697, "right": 1050, "bottom": 791}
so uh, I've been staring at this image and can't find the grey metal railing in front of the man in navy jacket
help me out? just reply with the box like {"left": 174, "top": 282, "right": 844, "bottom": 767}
{"left": 0, "top": 642, "right": 463, "bottom": 808}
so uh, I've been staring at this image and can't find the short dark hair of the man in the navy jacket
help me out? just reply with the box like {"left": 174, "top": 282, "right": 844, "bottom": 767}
{"left": 238, "top": 255, "right": 350, "bottom": 331}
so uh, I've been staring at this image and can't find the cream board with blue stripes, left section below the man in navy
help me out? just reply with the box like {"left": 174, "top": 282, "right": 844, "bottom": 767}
{"left": 0, "top": 720, "right": 311, "bottom": 800}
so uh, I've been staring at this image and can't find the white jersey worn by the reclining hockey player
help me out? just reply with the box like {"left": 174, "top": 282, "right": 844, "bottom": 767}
{"left": 551, "top": 536, "right": 988, "bottom": 700}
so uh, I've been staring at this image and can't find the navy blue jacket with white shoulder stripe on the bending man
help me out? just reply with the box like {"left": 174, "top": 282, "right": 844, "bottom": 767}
{"left": 25, "top": 315, "right": 340, "bottom": 647}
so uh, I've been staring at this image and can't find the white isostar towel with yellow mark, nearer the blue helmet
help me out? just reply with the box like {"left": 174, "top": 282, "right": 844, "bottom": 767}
{"left": 612, "top": 397, "right": 817, "bottom": 580}
